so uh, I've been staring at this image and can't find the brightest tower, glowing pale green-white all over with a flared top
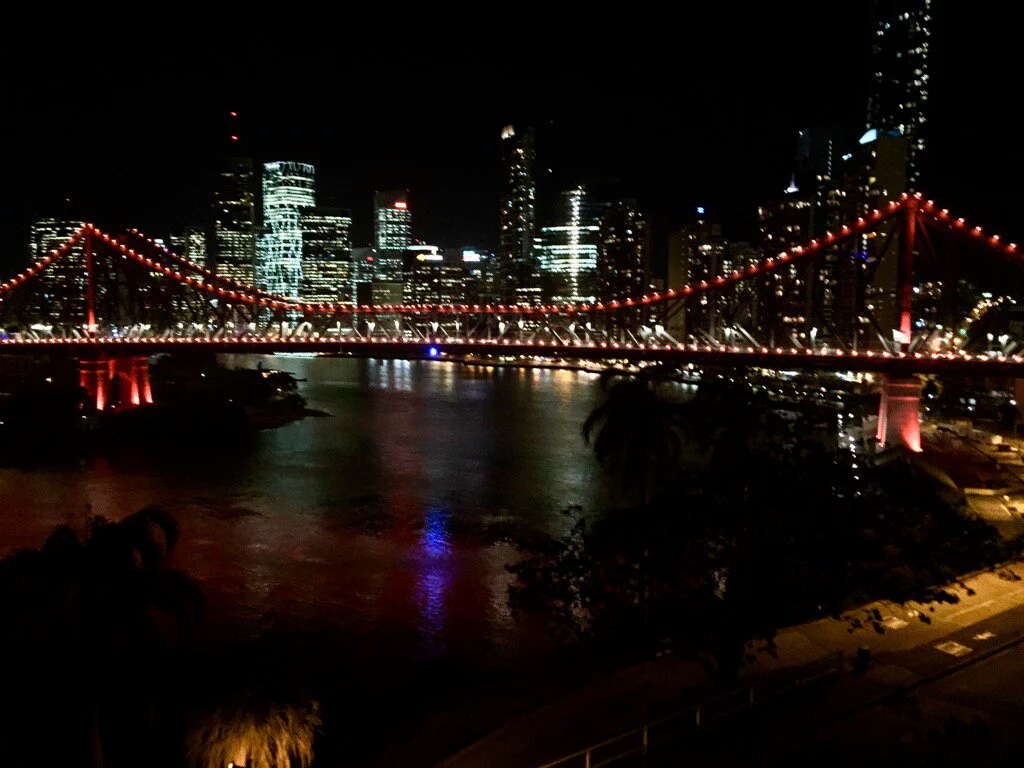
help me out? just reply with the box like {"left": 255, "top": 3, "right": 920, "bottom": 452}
{"left": 256, "top": 162, "right": 315, "bottom": 296}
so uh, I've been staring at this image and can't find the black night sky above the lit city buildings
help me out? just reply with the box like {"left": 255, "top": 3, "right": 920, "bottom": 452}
{"left": 0, "top": 6, "right": 1024, "bottom": 273}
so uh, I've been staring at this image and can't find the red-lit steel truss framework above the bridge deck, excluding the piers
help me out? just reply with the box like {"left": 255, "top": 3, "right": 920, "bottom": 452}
{"left": 0, "top": 195, "right": 1020, "bottom": 351}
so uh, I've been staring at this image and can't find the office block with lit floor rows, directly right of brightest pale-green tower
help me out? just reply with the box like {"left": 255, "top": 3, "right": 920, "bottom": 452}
{"left": 299, "top": 208, "right": 355, "bottom": 303}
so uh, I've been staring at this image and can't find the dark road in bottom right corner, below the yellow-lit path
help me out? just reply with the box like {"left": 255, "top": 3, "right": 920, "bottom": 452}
{"left": 745, "top": 607, "right": 1024, "bottom": 767}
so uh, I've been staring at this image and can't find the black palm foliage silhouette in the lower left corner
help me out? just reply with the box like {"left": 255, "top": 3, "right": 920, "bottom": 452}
{"left": 0, "top": 507, "right": 203, "bottom": 768}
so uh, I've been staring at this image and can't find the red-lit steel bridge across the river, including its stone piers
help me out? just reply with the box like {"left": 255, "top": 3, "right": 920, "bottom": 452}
{"left": 0, "top": 195, "right": 1024, "bottom": 451}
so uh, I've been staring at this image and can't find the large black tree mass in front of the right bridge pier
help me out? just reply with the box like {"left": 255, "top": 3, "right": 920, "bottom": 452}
{"left": 510, "top": 381, "right": 1019, "bottom": 675}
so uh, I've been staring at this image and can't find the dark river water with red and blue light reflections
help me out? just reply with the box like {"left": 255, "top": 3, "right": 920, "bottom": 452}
{"left": 0, "top": 356, "right": 607, "bottom": 663}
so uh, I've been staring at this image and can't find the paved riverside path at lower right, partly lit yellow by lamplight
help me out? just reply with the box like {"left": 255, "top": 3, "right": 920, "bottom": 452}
{"left": 440, "top": 562, "right": 1024, "bottom": 768}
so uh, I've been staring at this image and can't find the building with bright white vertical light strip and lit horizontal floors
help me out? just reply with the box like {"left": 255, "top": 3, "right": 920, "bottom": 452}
{"left": 536, "top": 186, "right": 599, "bottom": 303}
